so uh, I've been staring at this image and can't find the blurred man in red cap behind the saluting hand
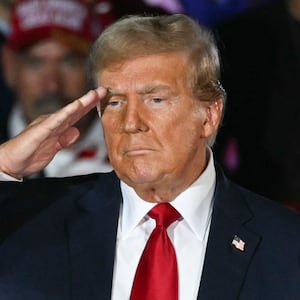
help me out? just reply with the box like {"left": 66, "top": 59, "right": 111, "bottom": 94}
{"left": 0, "top": 0, "right": 111, "bottom": 177}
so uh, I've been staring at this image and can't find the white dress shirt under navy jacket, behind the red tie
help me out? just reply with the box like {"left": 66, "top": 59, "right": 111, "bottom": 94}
{"left": 112, "top": 150, "right": 216, "bottom": 300}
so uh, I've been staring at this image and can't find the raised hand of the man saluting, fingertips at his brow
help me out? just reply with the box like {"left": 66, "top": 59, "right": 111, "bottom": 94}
{"left": 0, "top": 87, "right": 106, "bottom": 178}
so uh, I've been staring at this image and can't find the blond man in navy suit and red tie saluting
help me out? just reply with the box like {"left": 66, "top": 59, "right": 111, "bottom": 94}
{"left": 0, "top": 15, "right": 300, "bottom": 300}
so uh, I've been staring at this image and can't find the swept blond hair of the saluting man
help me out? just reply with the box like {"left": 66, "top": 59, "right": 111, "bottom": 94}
{"left": 90, "top": 14, "right": 226, "bottom": 145}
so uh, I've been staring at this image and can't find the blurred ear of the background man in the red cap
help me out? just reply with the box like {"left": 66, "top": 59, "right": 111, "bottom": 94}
{"left": 2, "top": 45, "right": 17, "bottom": 88}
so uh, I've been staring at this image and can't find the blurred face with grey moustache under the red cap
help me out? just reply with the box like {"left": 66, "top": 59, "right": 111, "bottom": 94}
{"left": 13, "top": 40, "right": 87, "bottom": 122}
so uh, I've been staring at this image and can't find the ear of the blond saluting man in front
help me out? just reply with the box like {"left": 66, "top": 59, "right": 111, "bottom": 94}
{"left": 201, "top": 98, "right": 223, "bottom": 138}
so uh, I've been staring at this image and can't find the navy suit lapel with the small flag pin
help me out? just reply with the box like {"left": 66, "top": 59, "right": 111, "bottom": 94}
{"left": 198, "top": 172, "right": 260, "bottom": 300}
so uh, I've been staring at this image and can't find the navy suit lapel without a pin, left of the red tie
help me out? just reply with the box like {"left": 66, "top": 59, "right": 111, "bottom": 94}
{"left": 67, "top": 172, "right": 121, "bottom": 300}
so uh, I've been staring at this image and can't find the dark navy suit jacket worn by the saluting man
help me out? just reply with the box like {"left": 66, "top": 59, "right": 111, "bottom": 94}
{"left": 0, "top": 171, "right": 300, "bottom": 300}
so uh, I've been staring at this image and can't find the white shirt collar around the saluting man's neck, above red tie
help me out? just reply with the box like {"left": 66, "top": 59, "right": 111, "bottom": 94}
{"left": 120, "top": 149, "right": 216, "bottom": 241}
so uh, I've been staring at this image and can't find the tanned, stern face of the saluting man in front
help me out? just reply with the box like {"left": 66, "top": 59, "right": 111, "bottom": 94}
{"left": 98, "top": 53, "right": 221, "bottom": 201}
